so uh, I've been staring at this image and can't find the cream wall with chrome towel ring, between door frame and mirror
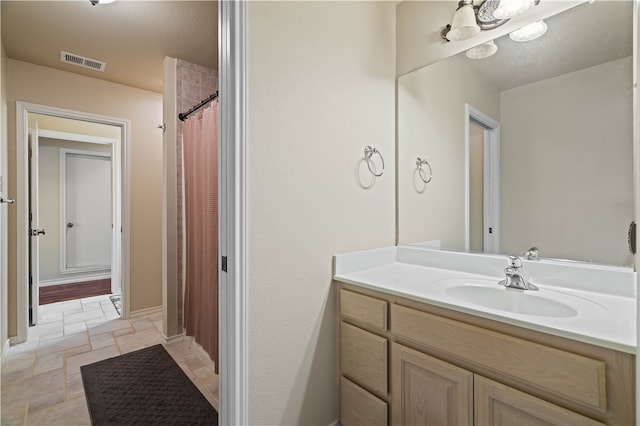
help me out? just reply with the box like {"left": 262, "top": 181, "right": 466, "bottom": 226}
{"left": 247, "top": 1, "right": 395, "bottom": 425}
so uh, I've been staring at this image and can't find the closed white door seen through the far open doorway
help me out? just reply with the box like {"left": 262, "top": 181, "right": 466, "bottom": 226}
{"left": 63, "top": 151, "right": 112, "bottom": 272}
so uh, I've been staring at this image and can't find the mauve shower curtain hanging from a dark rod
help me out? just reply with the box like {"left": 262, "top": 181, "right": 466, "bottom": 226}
{"left": 182, "top": 101, "right": 218, "bottom": 373}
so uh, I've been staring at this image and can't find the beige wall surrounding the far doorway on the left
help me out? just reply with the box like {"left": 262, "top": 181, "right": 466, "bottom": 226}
{"left": 7, "top": 59, "right": 162, "bottom": 335}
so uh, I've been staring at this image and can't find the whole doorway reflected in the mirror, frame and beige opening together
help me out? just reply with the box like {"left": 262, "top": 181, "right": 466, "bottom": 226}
{"left": 465, "top": 104, "right": 500, "bottom": 253}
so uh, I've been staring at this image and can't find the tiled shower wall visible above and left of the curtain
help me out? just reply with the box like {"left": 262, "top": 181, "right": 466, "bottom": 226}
{"left": 175, "top": 59, "right": 218, "bottom": 330}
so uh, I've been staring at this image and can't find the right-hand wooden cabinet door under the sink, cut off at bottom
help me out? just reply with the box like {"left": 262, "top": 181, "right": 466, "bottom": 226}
{"left": 474, "top": 375, "right": 603, "bottom": 426}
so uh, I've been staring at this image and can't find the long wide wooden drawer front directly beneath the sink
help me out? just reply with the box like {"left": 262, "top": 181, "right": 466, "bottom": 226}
{"left": 391, "top": 304, "right": 607, "bottom": 412}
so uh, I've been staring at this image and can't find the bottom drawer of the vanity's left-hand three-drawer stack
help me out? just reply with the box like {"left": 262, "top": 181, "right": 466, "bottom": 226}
{"left": 340, "top": 377, "right": 388, "bottom": 426}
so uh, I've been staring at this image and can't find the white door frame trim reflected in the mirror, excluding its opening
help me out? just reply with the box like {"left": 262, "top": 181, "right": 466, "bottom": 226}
{"left": 464, "top": 103, "right": 500, "bottom": 253}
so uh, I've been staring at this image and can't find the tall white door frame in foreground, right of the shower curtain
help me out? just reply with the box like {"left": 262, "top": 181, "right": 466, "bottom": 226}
{"left": 218, "top": 1, "right": 249, "bottom": 425}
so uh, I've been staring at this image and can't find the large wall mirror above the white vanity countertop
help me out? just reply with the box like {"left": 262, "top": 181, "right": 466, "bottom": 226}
{"left": 397, "top": 0, "right": 633, "bottom": 266}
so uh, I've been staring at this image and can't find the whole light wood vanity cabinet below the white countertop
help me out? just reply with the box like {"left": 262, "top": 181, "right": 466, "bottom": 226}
{"left": 338, "top": 283, "right": 635, "bottom": 426}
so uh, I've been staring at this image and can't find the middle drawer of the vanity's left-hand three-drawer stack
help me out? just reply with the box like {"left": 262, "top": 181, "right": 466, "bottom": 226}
{"left": 340, "top": 322, "right": 388, "bottom": 396}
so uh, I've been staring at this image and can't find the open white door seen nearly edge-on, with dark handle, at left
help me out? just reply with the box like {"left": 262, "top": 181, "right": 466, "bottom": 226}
{"left": 29, "top": 123, "right": 45, "bottom": 325}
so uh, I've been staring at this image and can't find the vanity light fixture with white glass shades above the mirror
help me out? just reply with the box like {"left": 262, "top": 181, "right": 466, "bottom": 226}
{"left": 440, "top": 0, "right": 540, "bottom": 41}
